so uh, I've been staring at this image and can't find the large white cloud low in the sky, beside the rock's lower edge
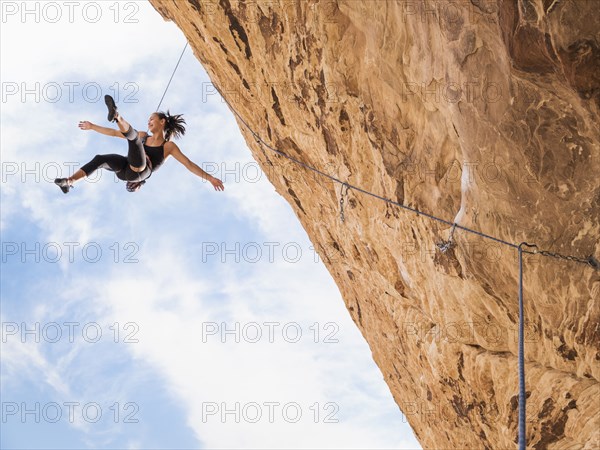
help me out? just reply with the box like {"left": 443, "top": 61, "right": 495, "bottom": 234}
{"left": 98, "top": 237, "right": 420, "bottom": 448}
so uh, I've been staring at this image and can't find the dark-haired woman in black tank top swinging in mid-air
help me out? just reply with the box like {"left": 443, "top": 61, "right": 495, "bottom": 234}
{"left": 54, "top": 95, "right": 225, "bottom": 194}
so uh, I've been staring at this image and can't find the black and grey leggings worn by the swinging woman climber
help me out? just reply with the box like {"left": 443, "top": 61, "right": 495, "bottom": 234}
{"left": 81, "top": 126, "right": 152, "bottom": 181}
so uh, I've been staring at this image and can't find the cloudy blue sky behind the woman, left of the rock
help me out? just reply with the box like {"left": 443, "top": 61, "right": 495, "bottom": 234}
{"left": 0, "top": 2, "right": 420, "bottom": 449}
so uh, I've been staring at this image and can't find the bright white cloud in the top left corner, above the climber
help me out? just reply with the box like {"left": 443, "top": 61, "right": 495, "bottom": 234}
{"left": 2, "top": 1, "right": 185, "bottom": 82}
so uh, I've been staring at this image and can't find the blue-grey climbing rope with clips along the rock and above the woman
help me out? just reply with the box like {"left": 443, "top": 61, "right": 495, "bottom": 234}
{"left": 156, "top": 42, "right": 600, "bottom": 450}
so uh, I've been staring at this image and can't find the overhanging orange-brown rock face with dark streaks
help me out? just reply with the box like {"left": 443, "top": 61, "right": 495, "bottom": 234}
{"left": 146, "top": 0, "right": 600, "bottom": 449}
